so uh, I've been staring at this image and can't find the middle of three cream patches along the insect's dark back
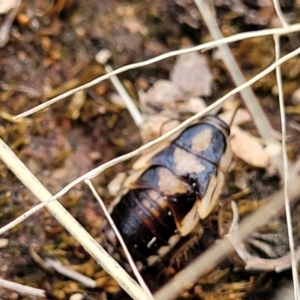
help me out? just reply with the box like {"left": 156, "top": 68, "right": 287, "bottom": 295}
{"left": 174, "top": 147, "right": 205, "bottom": 174}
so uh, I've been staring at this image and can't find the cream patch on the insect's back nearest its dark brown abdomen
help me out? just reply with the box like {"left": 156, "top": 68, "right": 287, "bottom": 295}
{"left": 158, "top": 168, "right": 187, "bottom": 195}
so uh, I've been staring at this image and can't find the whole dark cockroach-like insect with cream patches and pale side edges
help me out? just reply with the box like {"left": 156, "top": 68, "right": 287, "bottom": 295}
{"left": 104, "top": 115, "right": 231, "bottom": 265}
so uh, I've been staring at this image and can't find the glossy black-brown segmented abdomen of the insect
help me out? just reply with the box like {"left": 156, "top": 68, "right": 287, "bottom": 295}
{"left": 105, "top": 189, "right": 176, "bottom": 263}
